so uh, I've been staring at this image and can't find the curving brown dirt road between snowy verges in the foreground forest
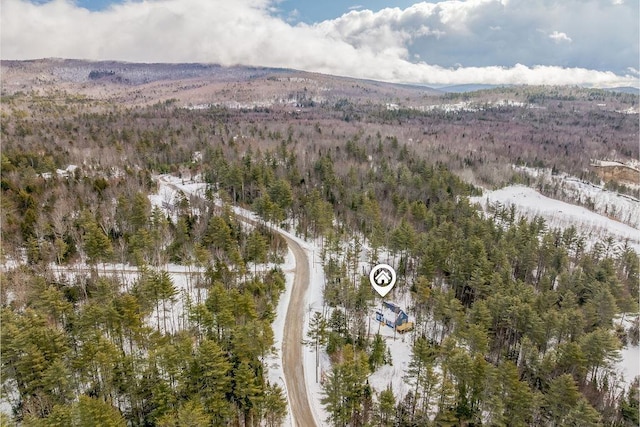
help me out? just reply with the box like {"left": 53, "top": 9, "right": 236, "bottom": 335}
{"left": 282, "top": 235, "right": 316, "bottom": 427}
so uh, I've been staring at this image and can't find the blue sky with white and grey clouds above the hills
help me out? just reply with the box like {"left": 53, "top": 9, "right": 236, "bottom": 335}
{"left": 0, "top": 0, "right": 640, "bottom": 86}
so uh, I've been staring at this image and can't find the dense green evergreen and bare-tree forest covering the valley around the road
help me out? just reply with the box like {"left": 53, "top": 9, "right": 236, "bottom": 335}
{"left": 1, "top": 82, "right": 640, "bottom": 426}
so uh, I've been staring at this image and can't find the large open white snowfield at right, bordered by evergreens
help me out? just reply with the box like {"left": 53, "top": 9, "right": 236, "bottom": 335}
{"left": 471, "top": 186, "right": 640, "bottom": 253}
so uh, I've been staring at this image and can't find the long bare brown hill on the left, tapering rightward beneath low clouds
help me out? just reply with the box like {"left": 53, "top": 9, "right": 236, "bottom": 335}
{"left": 0, "top": 58, "right": 442, "bottom": 108}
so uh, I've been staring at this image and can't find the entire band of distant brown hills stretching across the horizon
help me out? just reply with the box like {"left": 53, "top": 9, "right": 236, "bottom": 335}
{"left": 0, "top": 58, "right": 639, "bottom": 112}
